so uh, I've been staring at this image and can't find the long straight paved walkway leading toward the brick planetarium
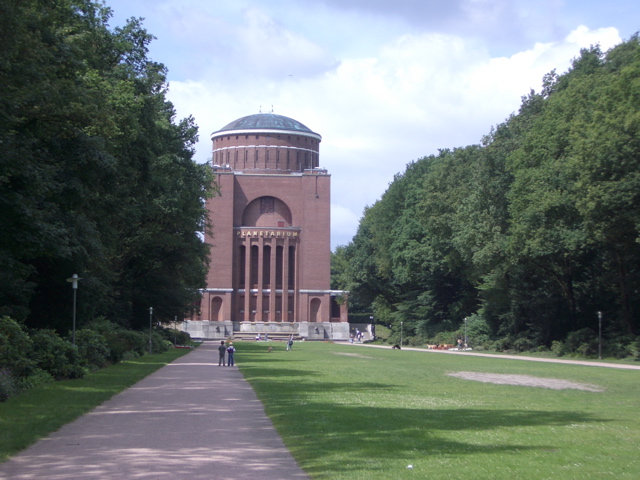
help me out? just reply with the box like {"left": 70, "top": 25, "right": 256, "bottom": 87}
{"left": 0, "top": 342, "right": 308, "bottom": 480}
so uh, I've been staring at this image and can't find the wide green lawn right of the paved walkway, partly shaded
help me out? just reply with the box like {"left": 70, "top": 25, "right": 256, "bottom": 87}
{"left": 237, "top": 342, "right": 640, "bottom": 480}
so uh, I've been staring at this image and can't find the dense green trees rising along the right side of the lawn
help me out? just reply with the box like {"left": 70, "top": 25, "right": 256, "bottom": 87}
{"left": 332, "top": 34, "right": 640, "bottom": 357}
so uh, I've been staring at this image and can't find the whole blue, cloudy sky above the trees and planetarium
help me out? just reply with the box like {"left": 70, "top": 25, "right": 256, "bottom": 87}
{"left": 106, "top": 0, "right": 640, "bottom": 249}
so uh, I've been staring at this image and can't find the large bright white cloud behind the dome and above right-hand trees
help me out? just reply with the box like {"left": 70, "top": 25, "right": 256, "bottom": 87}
{"left": 169, "top": 21, "right": 620, "bottom": 247}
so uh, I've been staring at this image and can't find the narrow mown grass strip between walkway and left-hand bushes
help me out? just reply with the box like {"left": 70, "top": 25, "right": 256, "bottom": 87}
{"left": 0, "top": 349, "right": 190, "bottom": 462}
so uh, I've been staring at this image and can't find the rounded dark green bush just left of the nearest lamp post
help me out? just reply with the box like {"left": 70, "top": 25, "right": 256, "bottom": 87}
{"left": 31, "top": 330, "right": 85, "bottom": 380}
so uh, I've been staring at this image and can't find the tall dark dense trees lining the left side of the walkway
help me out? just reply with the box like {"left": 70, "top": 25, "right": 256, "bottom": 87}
{"left": 0, "top": 0, "right": 213, "bottom": 334}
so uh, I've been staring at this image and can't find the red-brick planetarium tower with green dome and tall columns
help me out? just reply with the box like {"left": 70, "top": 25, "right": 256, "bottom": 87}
{"left": 185, "top": 113, "right": 349, "bottom": 340}
